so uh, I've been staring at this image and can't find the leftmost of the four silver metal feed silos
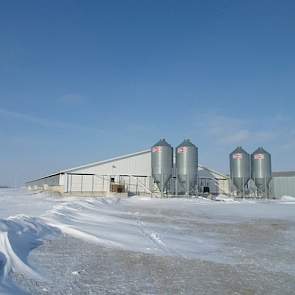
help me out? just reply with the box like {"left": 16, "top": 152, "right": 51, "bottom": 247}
{"left": 151, "top": 139, "right": 173, "bottom": 195}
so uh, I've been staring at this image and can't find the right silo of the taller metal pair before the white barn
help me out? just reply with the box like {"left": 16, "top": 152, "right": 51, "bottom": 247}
{"left": 176, "top": 139, "right": 198, "bottom": 195}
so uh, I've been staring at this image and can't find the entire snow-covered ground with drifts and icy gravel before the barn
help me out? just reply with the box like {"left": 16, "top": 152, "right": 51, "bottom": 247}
{"left": 0, "top": 189, "right": 295, "bottom": 294}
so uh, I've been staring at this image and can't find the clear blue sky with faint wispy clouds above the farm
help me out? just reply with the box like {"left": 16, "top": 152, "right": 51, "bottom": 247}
{"left": 0, "top": 0, "right": 295, "bottom": 184}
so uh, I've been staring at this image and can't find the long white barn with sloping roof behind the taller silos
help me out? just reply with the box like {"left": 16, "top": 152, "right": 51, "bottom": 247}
{"left": 26, "top": 150, "right": 229, "bottom": 195}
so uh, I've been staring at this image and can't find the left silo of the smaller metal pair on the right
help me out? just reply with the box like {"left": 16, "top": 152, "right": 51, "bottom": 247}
{"left": 229, "top": 147, "right": 251, "bottom": 194}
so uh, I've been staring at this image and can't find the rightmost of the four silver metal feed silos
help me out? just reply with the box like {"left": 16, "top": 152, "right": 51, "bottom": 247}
{"left": 251, "top": 147, "right": 272, "bottom": 197}
